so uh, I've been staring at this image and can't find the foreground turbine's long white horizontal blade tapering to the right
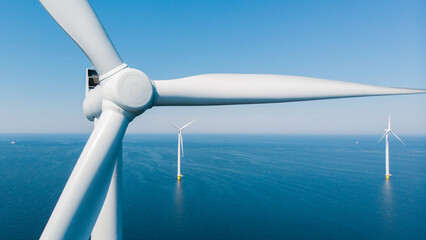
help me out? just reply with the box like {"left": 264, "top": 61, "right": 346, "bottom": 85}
{"left": 154, "top": 74, "right": 426, "bottom": 106}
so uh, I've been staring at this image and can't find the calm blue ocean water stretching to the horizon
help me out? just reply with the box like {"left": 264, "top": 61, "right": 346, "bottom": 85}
{"left": 0, "top": 134, "right": 426, "bottom": 240}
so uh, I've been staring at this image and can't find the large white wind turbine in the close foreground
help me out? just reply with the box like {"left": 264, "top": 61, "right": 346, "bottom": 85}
{"left": 40, "top": 0, "right": 426, "bottom": 240}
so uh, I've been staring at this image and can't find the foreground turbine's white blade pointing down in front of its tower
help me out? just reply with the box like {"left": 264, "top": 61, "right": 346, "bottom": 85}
{"left": 40, "top": 110, "right": 129, "bottom": 240}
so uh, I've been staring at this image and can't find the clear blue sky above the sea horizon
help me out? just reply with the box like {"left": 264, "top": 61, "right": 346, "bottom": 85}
{"left": 0, "top": 0, "right": 426, "bottom": 134}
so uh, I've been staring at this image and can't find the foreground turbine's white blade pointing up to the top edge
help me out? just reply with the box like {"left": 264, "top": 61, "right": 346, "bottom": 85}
{"left": 40, "top": 0, "right": 123, "bottom": 79}
